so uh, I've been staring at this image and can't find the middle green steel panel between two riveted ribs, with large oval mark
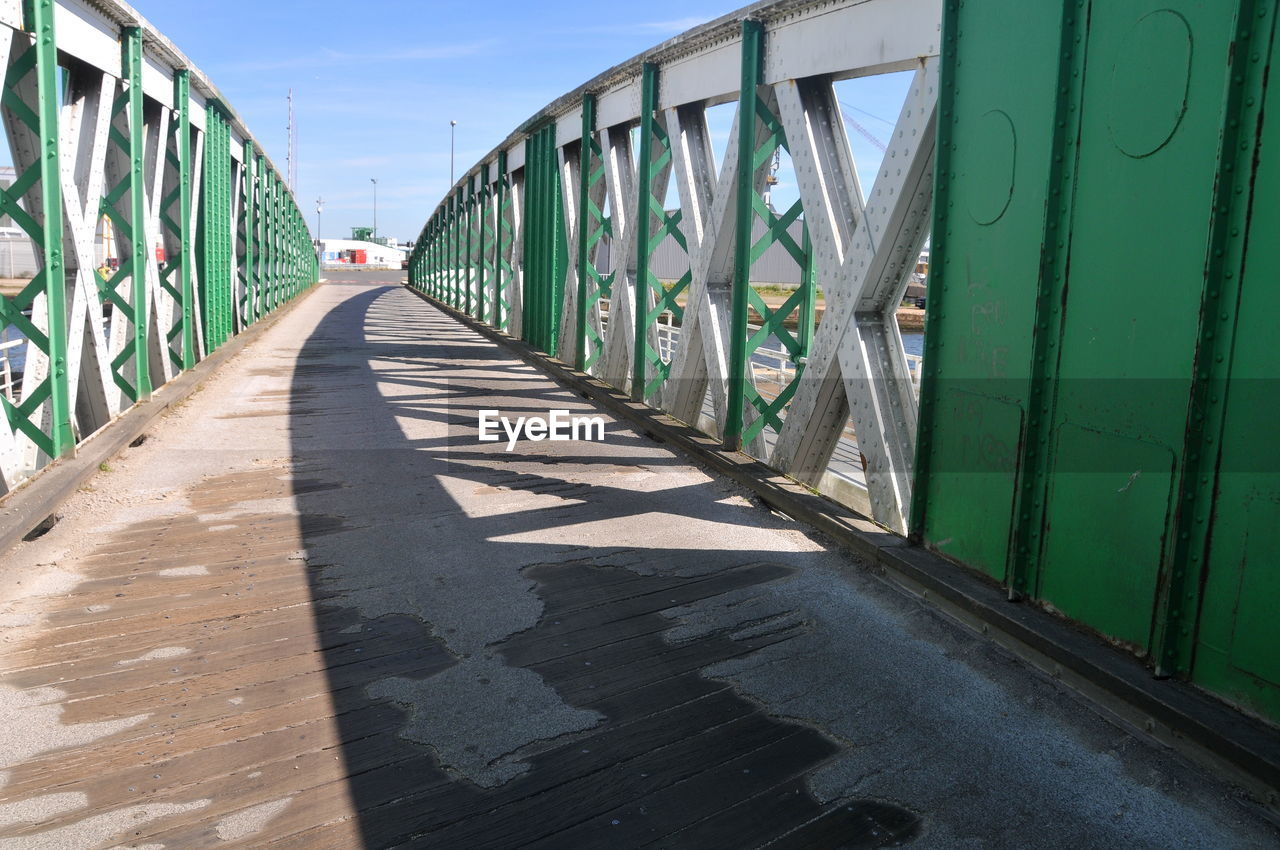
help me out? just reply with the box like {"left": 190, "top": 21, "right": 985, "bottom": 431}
{"left": 1037, "top": 0, "right": 1233, "bottom": 646}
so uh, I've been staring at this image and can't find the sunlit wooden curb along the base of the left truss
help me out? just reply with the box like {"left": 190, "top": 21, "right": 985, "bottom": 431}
{"left": 0, "top": 284, "right": 319, "bottom": 554}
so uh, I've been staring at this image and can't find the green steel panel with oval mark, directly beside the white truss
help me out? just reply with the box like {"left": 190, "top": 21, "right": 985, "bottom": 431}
{"left": 913, "top": 0, "right": 1062, "bottom": 580}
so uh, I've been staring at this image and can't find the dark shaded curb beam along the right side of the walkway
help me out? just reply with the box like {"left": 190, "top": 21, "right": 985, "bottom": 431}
{"left": 404, "top": 284, "right": 1280, "bottom": 818}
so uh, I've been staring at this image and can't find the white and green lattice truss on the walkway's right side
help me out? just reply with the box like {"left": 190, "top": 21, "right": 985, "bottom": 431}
{"left": 410, "top": 0, "right": 941, "bottom": 530}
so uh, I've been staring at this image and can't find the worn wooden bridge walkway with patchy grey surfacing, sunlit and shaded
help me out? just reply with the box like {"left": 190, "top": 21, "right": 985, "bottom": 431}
{"left": 0, "top": 273, "right": 1277, "bottom": 850}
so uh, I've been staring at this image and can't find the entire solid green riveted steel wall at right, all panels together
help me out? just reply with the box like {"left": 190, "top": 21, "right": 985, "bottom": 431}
{"left": 911, "top": 0, "right": 1280, "bottom": 719}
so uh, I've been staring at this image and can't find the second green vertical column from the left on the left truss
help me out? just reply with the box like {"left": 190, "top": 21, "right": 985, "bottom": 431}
{"left": 122, "top": 27, "right": 151, "bottom": 402}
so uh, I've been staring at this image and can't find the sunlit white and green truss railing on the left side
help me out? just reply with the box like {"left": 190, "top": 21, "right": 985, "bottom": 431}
{"left": 0, "top": 0, "right": 317, "bottom": 493}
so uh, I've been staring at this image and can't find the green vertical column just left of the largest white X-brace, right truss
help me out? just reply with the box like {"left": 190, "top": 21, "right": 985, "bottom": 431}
{"left": 724, "top": 20, "right": 763, "bottom": 451}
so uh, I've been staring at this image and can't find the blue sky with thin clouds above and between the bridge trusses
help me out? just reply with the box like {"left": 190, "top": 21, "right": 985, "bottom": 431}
{"left": 133, "top": 0, "right": 906, "bottom": 241}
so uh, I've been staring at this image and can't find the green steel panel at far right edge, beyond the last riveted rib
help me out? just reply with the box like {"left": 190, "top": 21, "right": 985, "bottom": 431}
{"left": 1192, "top": 6, "right": 1280, "bottom": 719}
